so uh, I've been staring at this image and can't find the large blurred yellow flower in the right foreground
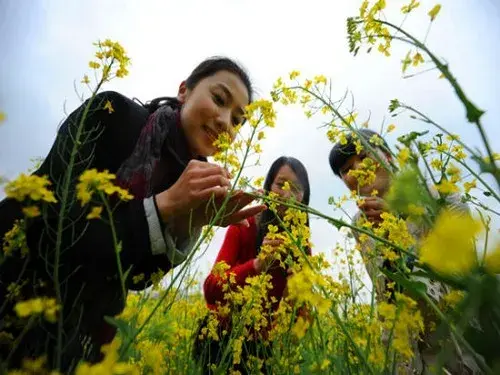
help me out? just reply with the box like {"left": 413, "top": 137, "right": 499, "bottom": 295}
{"left": 420, "top": 210, "right": 480, "bottom": 275}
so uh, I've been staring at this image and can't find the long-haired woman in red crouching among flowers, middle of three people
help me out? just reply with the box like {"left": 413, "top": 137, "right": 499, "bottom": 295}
{"left": 195, "top": 156, "right": 310, "bottom": 373}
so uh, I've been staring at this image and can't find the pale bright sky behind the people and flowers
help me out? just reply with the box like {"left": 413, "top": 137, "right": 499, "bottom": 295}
{"left": 0, "top": 0, "right": 500, "bottom": 300}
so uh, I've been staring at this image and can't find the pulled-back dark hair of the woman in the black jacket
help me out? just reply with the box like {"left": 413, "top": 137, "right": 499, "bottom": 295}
{"left": 144, "top": 56, "right": 253, "bottom": 113}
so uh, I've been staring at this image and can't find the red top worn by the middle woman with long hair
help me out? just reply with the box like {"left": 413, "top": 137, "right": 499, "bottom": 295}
{"left": 203, "top": 217, "right": 287, "bottom": 310}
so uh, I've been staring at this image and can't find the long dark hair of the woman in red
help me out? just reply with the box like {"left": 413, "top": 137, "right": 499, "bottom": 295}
{"left": 255, "top": 156, "right": 311, "bottom": 253}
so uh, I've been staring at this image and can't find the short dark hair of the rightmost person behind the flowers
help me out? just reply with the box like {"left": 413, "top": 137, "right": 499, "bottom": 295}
{"left": 328, "top": 129, "right": 390, "bottom": 177}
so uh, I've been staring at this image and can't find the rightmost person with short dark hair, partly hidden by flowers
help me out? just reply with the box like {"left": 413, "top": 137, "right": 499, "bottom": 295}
{"left": 329, "top": 128, "right": 477, "bottom": 374}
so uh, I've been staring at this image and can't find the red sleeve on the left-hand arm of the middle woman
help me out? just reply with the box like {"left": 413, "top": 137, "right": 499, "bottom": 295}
{"left": 203, "top": 225, "right": 258, "bottom": 305}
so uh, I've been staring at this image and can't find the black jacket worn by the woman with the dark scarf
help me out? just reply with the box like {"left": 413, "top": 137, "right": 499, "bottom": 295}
{"left": 0, "top": 92, "right": 203, "bottom": 366}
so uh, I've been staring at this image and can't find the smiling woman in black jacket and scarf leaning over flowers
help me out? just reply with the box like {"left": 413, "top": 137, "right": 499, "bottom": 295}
{"left": 0, "top": 58, "right": 265, "bottom": 371}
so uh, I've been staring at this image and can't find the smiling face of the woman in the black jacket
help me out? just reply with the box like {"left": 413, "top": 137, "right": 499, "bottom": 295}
{"left": 177, "top": 70, "right": 249, "bottom": 157}
